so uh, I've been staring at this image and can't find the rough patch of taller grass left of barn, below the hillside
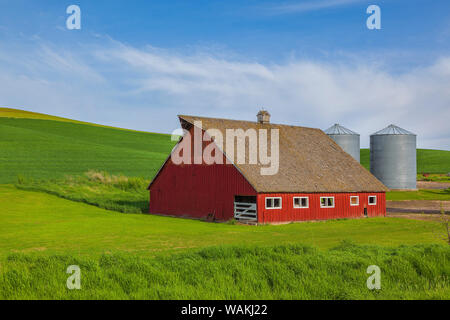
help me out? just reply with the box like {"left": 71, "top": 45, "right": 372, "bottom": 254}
{"left": 16, "top": 170, "right": 149, "bottom": 213}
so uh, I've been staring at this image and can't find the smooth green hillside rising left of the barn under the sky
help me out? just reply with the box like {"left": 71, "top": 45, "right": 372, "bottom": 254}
{"left": 0, "top": 109, "right": 173, "bottom": 183}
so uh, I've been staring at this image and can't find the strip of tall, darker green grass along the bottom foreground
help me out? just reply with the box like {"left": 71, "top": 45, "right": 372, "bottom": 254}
{"left": 0, "top": 243, "right": 450, "bottom": 299}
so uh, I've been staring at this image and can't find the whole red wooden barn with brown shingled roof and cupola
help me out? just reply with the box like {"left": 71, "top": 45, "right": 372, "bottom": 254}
{"left": 148, "top": 112, "right": 387, "bottom": 224}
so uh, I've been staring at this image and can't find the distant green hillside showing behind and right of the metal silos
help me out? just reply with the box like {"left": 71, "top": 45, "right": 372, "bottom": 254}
{"left": 361, "top": 149, "right": 450, "bottom": 173}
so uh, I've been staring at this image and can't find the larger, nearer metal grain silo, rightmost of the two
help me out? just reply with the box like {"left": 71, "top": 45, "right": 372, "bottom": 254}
{"left": 370, "top": 124, "right": 417, "bottom": 190}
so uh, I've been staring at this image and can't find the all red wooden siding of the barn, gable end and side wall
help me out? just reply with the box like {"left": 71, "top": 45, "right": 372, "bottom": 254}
{"left": 149, "top": 124, "right": 386, "bottom": 223}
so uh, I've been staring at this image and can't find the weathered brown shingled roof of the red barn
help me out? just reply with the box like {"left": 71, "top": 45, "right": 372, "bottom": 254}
{"left": 179, "top": 115, "right": 388, "bottom": 193}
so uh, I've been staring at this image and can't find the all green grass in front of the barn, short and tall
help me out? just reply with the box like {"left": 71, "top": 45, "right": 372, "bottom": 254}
{"left": 0, "top": 185, "right": 450, "bottom": 299}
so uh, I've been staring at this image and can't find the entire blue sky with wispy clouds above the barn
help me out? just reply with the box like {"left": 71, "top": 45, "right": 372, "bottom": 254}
{"left": 0, "top": 0, "right": 450, "bottom": 150}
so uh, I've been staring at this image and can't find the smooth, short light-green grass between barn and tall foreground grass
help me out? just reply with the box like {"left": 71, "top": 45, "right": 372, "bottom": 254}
{"left": 0, "top": 186, "right": 445, "bottom": 257}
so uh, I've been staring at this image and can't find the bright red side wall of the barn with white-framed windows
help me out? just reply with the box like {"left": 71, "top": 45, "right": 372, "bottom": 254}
{"left": 257, "top": 192, "right": 386, "bottom": 223}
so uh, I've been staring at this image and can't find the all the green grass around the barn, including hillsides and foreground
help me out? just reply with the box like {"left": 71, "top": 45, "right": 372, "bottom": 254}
{"left": 0, "top": 108, "right": 450, "bottom": 299}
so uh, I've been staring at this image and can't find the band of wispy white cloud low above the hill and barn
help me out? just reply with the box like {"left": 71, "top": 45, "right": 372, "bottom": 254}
{"left": 0, "top": 42, "right": 450, "bottom": 150}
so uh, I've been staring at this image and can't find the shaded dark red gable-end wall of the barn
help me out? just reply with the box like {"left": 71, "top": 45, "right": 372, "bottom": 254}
{"left": 149, "top": 125, "right": 256, "bottom": 220}
